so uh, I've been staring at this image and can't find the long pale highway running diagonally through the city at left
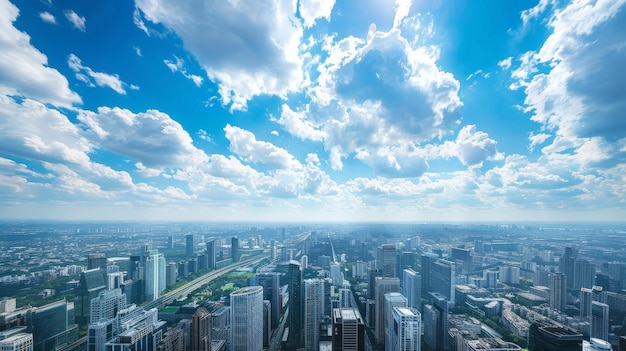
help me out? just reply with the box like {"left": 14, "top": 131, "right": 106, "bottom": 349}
{"left": 142, "top": 254, "right": 269, "bottom": 310}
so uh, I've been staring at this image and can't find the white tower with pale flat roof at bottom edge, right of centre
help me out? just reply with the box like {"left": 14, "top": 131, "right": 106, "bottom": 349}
{"left": 385, "top": 307, "right": 422, "bottom": 351}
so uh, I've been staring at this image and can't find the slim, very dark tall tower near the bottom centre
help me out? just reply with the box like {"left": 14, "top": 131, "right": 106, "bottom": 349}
{"left": 287, "top": 261, "right": 304, "bottom": 349}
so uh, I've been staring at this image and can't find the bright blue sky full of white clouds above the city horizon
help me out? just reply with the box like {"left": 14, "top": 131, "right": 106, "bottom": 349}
{"left": 0, "top": 0, "right": 626, "bottom": 222}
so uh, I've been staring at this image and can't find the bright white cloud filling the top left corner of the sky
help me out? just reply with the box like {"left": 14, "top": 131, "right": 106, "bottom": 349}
{"left": 0, "top": 0, "right": 82, "bottom": 108}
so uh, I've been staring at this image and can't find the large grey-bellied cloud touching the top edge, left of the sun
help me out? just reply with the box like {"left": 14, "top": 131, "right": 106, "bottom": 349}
{"left": 136, "top": 0, "right": 304, "bottom": 111}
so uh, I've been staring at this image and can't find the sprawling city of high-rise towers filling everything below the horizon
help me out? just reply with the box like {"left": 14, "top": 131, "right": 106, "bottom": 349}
{"left": 0, "top": 222, "right": 626, "bottom": 351}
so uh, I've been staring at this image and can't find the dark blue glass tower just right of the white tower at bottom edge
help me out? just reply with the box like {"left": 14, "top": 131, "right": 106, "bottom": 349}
{"left": 422, "top": 293, "right": 448, "bottom": 351}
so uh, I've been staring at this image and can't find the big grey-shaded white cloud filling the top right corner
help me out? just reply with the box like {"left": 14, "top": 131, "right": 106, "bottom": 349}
{"left": 513, "top": 0, "right": 626, "bottom": 157}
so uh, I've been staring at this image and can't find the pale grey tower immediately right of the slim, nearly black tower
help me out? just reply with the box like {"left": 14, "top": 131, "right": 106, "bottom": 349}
{"left": 303, "top": 279, "right": 324, "bottom": 351}
